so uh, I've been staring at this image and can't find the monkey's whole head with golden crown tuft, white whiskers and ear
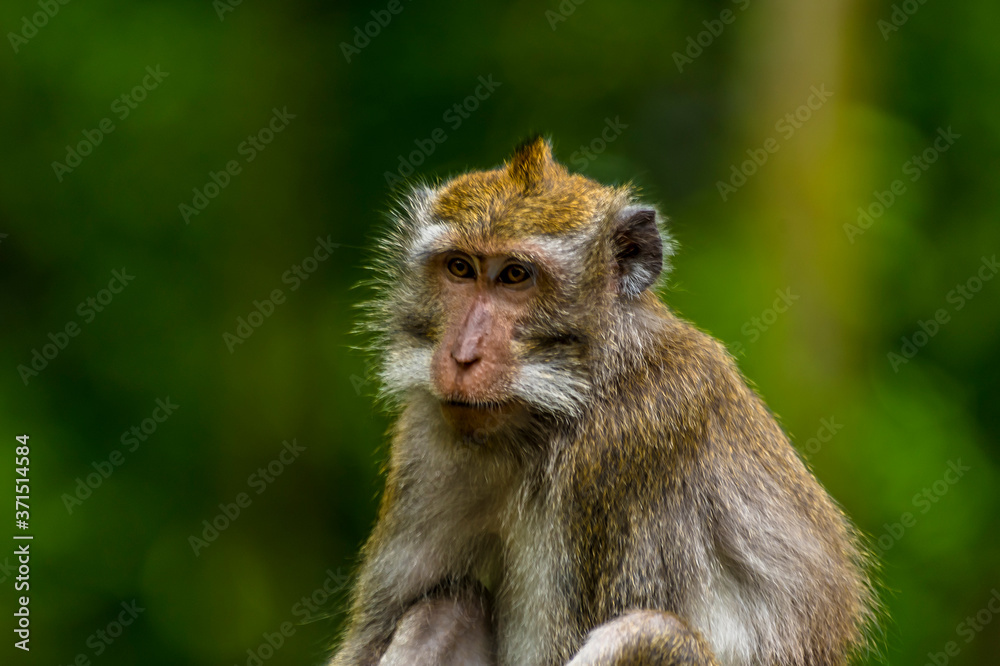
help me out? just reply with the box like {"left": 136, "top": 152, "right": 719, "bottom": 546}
{"left": 372, "top": 138, "right": 672, "bottom": 434}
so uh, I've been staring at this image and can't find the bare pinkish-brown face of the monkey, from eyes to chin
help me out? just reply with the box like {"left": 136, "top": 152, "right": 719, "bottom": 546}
{"left": 429, "top": 251, "right": 538, "bottom": 432}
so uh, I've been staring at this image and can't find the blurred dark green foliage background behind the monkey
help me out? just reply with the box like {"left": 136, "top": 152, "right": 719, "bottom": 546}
{"left": 0, "top": 0, "right": 1000, "bottom": 666}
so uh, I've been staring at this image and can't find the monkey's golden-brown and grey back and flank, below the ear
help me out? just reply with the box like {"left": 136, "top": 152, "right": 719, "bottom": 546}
{"left": 558, "top": 306, "right": 872, "bottom": 664}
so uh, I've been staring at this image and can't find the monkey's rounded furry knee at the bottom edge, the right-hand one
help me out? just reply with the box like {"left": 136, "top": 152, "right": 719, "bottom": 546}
{"left": 567, "top": 610, "right": 719, "bottom": 666}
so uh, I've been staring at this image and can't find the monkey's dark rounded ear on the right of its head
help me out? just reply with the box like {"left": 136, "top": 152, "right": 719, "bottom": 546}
{"left": 613, "top": 206, "right": 663, "bottom": 296}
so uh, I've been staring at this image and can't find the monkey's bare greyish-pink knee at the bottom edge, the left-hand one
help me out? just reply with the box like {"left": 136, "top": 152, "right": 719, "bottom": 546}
{"left": 379, "top": 591, "right": 496, "bottom": 666}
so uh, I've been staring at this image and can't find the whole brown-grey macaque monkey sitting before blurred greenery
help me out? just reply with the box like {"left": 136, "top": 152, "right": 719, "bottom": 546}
{"left": 328, "top": 137, "right": 878, "bottom": 666}
